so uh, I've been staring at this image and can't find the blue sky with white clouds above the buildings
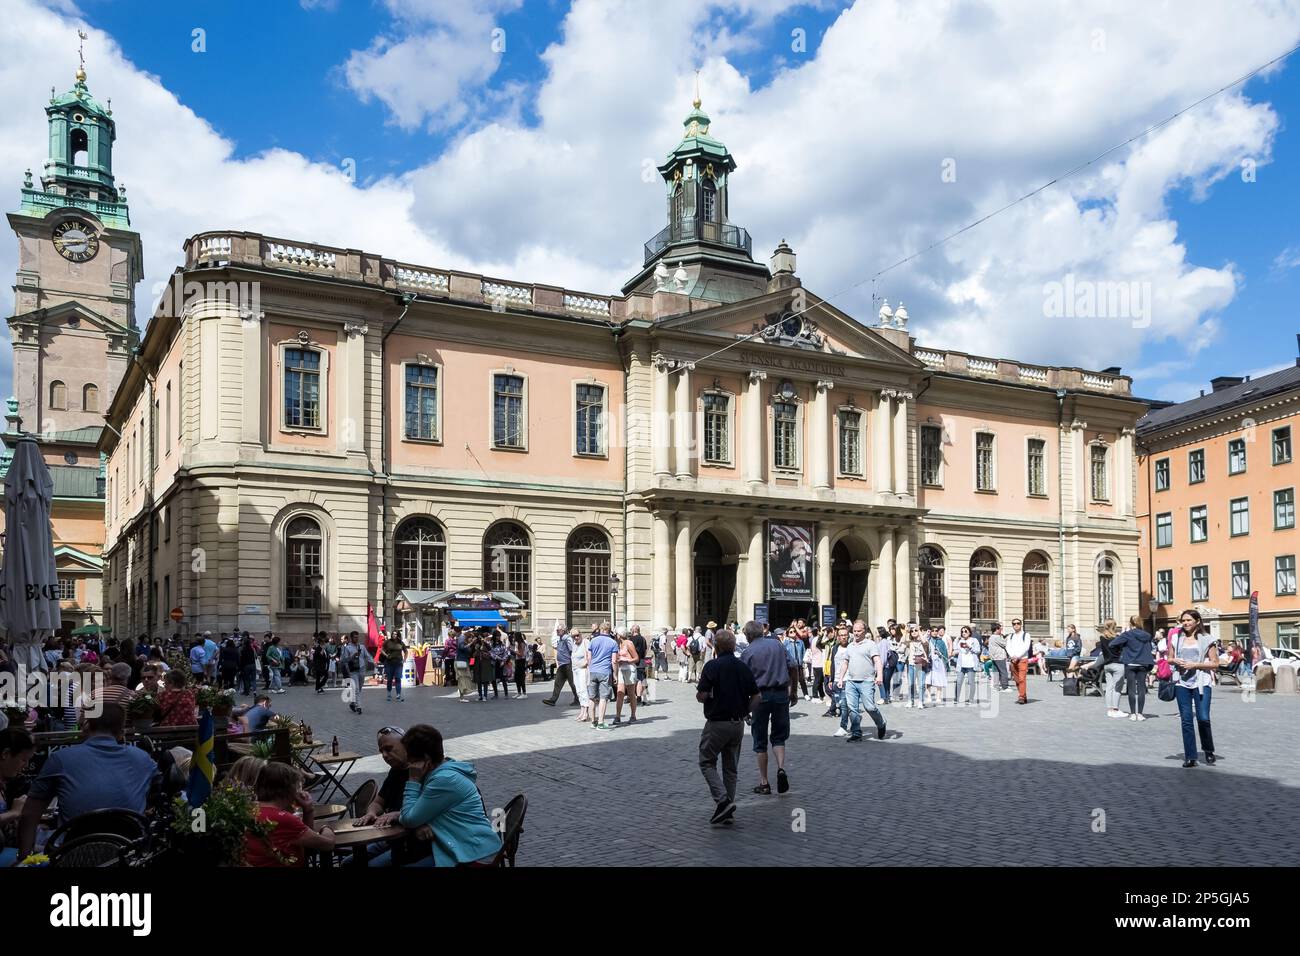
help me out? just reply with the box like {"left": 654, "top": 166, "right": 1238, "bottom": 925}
{"left": 0, "top": 0, "right": 1300, "bottom": 398}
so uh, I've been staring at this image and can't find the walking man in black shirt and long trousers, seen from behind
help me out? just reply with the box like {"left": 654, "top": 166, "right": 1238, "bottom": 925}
{"left": 696, "top": 631, "right": 758, "bottom": 826}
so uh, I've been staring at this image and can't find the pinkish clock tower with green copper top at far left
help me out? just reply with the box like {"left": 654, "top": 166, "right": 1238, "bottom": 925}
{"left": 8, "top": 55, "right": 143, "bottom": 444}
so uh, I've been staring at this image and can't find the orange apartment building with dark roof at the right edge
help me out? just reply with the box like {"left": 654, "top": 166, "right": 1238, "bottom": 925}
{"left": 1138, "top": 359, "right": 1300, "bottom": 649}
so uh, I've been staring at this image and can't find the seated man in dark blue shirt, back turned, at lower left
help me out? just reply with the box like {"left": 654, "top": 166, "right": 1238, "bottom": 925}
{"left": 18, "top": 704, "right": 159, "bottom": 860}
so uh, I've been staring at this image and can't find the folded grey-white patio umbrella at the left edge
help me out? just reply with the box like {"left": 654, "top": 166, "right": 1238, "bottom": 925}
{"left": 0, "top": 436, "right": 60, "bottom": 672}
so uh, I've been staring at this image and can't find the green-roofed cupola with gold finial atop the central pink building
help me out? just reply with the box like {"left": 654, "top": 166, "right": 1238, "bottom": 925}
{"left": 623, "top": 81, "right": 768, "bottom": 302}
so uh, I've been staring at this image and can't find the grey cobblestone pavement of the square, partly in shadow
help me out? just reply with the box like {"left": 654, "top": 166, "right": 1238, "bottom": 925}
{"left": 266, "top": 676, "right": 1300, "bottom": 866}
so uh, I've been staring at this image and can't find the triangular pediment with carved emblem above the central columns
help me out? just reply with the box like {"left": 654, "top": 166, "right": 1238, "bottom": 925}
{"left": 655, "top": 289, "right": 926, "bottom": 371}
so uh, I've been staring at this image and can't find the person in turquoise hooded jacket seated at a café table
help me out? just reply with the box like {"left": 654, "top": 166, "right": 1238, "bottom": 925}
{"left": 373, "top": 723, "right": 501, "bottom": 866}
